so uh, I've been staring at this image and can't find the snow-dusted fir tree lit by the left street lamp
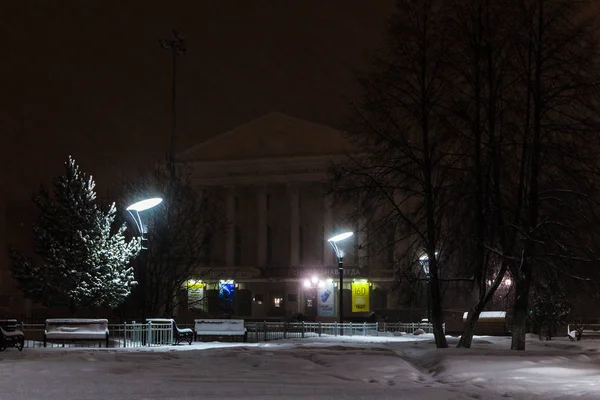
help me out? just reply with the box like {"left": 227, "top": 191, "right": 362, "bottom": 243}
{"left": 10, "top": 156, "right": 140, "bottom": 311}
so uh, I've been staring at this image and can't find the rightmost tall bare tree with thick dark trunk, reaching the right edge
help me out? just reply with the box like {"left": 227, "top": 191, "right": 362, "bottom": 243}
{"left": 497, "top": 0, "right": 600, "bottom": 350}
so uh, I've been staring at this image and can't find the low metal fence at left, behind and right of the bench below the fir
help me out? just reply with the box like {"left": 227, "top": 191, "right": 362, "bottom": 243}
{"left": 19, "top": 322, "right": 173, "bottom": 347}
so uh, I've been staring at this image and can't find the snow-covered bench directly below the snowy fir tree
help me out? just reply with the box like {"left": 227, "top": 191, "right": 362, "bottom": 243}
{"left": 44, "top": 318, "right": 109, "bottom": 347}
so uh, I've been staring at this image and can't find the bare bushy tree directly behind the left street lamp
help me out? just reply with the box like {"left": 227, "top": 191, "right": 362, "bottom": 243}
{"left": 126, "top": 162, "right": 225, "bottom": 317}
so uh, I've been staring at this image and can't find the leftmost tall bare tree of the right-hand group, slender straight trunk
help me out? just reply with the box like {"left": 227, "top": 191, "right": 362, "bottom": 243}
{"left": 333, "top": 0, "right": 460, "bottom": 347}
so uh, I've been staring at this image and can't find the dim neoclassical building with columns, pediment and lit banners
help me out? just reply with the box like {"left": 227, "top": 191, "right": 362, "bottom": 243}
{"left": 178, "top": 113, "right": 394, "bottom": 319}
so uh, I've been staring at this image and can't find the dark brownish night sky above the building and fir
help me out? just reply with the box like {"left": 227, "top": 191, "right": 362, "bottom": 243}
{"left": 0, "top": 0, "right": 393, "bottom": 199}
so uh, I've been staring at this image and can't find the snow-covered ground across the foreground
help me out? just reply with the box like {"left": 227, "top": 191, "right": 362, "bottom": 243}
{"left": 0, "top": 335, "right": 600, "bottom": 400}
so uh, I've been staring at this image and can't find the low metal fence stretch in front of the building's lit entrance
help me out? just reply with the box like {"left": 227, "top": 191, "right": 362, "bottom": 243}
{"left": 246, "top": 322, "right": 379, "bottom": 342}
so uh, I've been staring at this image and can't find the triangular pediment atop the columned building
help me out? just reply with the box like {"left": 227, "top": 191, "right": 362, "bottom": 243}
{"left": 177, "top": 113, "right": 352, "bottom": 162}
